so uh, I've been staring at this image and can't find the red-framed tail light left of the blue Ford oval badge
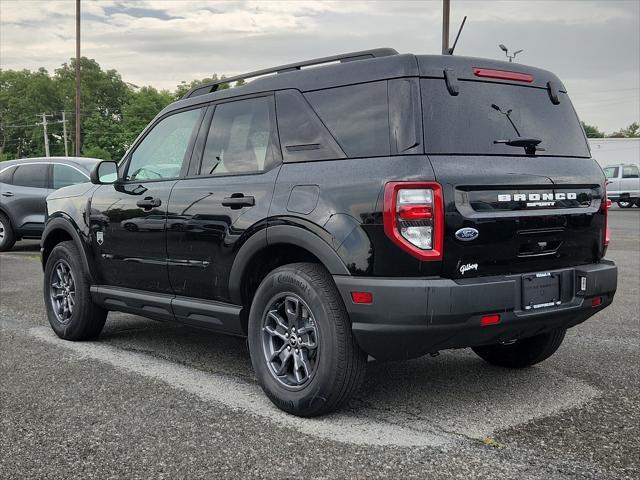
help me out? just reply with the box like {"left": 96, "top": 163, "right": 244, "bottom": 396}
{"left": 383, "top": 182, "right": 444, "bottom": 260}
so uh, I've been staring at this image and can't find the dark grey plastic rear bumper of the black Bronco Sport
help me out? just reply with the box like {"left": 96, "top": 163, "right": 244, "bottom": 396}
{"left": 334, "top": 260, "right": 618, "bottom": 360}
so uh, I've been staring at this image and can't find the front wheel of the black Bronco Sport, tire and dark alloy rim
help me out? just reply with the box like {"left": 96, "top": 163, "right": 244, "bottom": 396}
{"left": 43, "top": 242, "right": 107, "bottom": 340}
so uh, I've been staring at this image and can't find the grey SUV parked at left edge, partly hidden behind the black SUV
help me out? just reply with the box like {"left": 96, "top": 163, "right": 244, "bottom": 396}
{"left": 0, "top": 157, "right": 99, "bottom": 252}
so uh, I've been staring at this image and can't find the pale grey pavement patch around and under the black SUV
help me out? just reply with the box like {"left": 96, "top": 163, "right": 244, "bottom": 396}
{"left": 29, "top": 327, "right": 600, "bottom": 447}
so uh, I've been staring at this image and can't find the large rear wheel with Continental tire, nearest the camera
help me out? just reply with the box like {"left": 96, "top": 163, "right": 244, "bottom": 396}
{"left": 248, "top": 263, "right": 366, "bottom": 417}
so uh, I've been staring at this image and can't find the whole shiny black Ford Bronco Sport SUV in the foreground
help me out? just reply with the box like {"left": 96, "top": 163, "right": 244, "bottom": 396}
{"left": 42, "top": 49, "right": 617, "bottom": 416}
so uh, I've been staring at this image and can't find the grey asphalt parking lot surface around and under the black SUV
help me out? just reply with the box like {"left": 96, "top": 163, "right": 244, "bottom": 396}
{"left": 0, "top": 208, "right": 640, "bottom": 479}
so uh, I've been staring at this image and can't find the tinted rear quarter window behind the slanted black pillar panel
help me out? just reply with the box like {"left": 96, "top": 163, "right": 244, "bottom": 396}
{"left": 305, "top": 82, "right": 391, "bottom": 157}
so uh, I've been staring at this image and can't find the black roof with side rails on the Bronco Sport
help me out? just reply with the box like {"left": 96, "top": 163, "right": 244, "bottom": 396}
{"left": 160, "top": 48, "right": 566, "bottom": 114}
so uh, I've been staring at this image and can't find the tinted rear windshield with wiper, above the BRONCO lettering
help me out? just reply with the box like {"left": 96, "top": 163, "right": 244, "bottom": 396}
{"left": 421, "top": 79, "right": 590, "bottom": 158}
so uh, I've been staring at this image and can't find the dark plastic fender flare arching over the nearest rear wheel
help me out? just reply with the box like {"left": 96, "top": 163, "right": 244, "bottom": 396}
{"left": 229, "top": 225, "right": 351, "bottom": 305}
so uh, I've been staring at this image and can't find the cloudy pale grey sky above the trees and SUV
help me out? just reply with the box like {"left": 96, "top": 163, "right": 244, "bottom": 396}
{"left": 0, "top": 0, "right": 640, "bottom": 132}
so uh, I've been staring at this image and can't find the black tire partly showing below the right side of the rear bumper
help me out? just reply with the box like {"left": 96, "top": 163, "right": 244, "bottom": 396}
{"left": 472, "top": 329, "right": 567, "bottom": 368}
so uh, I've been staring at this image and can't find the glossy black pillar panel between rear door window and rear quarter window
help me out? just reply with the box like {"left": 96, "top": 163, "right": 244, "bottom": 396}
{"left": 276, "top": 90, "right": 345, "bottom": 162}
